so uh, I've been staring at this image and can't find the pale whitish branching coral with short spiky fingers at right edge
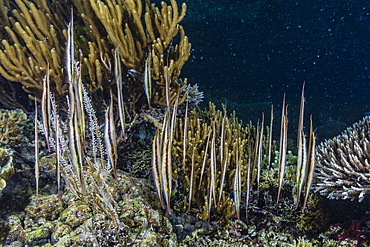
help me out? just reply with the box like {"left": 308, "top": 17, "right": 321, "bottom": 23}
{"left": 314, "top": 116, "right": 370, "bottom": 201}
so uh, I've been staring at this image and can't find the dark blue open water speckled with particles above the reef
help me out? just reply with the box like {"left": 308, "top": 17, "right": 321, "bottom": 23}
{"left": 182, "top": 0, "right": 370, "bottom": 131}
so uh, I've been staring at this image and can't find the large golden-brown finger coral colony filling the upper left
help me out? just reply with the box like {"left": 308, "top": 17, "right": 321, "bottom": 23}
{"left": 0, "top": 0, "right": 191, "bottom": 111}
